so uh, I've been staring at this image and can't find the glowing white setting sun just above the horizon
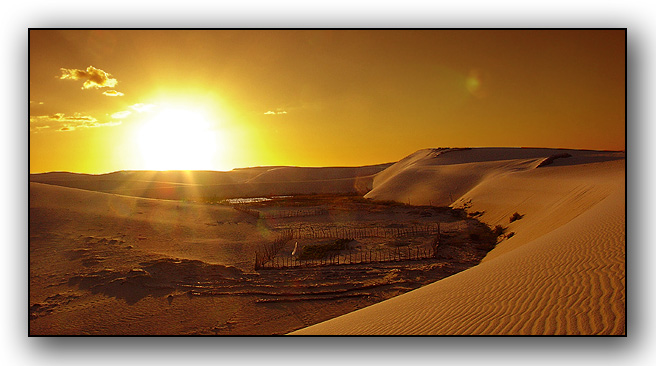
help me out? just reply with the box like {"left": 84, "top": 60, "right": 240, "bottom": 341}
{"left": 136, "top": 107, "right": 223, "bottom": 170}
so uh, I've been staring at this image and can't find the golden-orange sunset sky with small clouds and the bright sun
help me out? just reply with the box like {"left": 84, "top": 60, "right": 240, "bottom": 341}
{"left": 29, "top": 30, "right": 626, "bottom": 173}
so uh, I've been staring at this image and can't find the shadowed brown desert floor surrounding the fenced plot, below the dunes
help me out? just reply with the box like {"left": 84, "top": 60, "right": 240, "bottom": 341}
{"left": 29, "top": 182, "right": 484, "bottom": 335}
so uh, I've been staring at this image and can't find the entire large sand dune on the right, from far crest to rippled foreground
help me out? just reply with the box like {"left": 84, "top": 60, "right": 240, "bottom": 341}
{"left": 294, "top": 149, "right": 626, "bottom": 334}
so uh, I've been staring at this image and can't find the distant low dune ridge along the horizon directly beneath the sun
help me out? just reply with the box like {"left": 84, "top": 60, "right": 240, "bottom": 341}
{"left": 30, "top": 164, "right": 390, "bottom": 200}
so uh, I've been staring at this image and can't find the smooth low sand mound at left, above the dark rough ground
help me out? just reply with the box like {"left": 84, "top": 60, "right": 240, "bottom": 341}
{"left": 30, "top": 183, "right": 268, "bottom": 268}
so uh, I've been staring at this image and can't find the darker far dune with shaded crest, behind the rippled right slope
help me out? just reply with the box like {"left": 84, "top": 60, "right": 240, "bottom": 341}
{"left": 365, "top": 148, "right": 623, "bottom": 206}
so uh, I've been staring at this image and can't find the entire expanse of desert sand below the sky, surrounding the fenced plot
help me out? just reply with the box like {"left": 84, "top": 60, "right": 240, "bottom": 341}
{"left": 30, "top": 148, "right": 626, "bottom": 335}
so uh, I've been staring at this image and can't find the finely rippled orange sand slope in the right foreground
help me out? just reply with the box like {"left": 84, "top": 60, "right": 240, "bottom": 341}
{"left": 292, "top": 151, "right": 626, "bottom": 335}
